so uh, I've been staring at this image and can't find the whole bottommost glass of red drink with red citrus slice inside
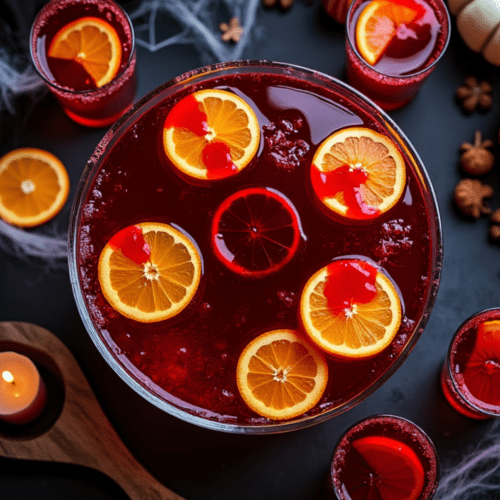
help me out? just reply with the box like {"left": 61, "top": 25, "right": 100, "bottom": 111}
{"left": 330, "top": 416, "right": 438, "bottom": 500}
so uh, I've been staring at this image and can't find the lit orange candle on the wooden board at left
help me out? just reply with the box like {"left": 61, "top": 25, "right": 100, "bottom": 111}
{"left": 0, "top": 352, "right": 47, "bottom": 424}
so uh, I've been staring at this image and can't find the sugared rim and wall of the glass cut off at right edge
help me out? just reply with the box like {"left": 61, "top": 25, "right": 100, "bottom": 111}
{"left": 441, "top": 308, "right": 500, "bottom": 420}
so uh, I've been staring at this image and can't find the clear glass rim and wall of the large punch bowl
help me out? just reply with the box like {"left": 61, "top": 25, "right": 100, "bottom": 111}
{"left": 69, "top": 61, "right": 442, "bottom": 434}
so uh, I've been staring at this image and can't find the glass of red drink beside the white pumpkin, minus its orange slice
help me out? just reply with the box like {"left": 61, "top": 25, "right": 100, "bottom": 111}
{"left": 346, "top": 0, "right": 449, "bottom": 110}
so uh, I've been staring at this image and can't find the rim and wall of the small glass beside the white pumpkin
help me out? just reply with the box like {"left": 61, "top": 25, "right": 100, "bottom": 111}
{"left": 346, "top": 0, "right": 450, "bottom": 111}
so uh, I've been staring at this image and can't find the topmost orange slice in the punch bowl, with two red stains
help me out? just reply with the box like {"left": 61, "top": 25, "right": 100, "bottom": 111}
{"left": 163, "top": 89, "right": 260, "bottom": 180}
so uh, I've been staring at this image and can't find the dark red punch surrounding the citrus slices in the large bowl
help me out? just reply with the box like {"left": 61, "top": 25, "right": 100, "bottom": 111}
{"left": 77, "top": 74, "right": 433, "bottom": 425}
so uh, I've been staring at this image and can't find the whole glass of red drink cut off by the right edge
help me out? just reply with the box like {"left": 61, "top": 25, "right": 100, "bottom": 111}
{"left": 441, "top": 310, "right": 500, "bottom": 419}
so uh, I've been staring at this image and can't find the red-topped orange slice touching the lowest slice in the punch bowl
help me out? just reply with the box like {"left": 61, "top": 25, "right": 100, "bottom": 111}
{"left": 300, "top": 259, "right": 401, "bottom": 360}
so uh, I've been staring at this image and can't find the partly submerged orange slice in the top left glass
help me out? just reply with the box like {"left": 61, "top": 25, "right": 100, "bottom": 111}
{"left": 47, "top": 17, "right": 122, "bottom": 87}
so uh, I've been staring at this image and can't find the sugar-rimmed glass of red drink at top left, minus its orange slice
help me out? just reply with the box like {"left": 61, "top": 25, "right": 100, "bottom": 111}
{"left": 30, "top": 0, "right": 137, "bottom": 127}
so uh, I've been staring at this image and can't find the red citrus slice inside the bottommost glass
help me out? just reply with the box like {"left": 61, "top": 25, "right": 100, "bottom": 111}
{"left": 352, "top": 436, "right": 425, "bottom": 500}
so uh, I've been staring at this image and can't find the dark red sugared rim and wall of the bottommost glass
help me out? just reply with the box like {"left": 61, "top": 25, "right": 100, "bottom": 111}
{"left": 327, "top": 415, "right": 439, "bottom": 500}
